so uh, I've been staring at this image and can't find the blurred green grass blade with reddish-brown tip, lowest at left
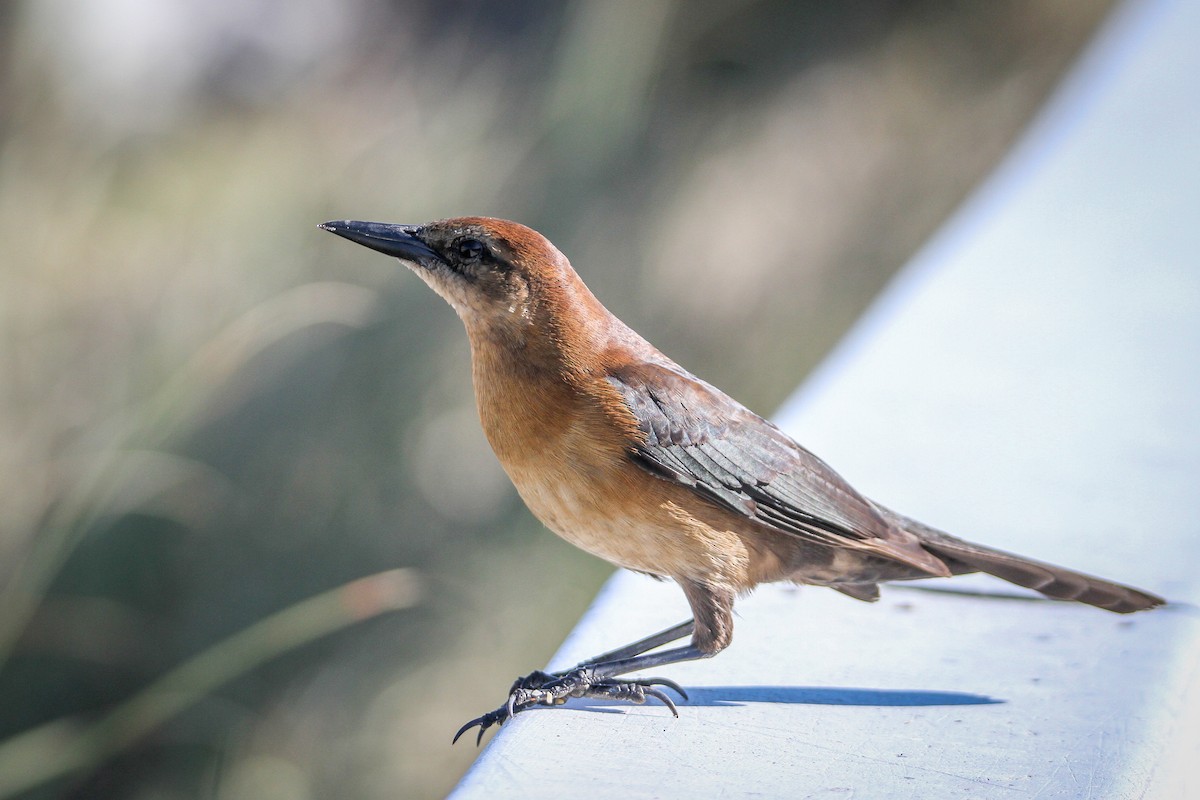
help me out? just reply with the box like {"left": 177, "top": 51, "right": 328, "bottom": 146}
{"left": 0, "top": 570, "right": 420, "bottom": 799}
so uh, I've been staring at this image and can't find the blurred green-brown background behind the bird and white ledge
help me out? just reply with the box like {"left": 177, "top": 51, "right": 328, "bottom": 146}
{"left": 0, "top": 0, "right": 1111, "bottom": 800}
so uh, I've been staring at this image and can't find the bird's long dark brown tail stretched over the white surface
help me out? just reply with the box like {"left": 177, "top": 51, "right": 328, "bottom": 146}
{"left": 881, "top": 509, "right": 1166, "bottom": 614}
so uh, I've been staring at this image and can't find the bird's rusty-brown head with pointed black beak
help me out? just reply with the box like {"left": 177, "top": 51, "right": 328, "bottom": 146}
{"left": 320, "top": 217, "right": 606, "bottom": 341}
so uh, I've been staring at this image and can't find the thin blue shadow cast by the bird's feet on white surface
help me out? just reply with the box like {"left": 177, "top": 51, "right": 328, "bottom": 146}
{"left": 572, "top": 686, "right": 1007, "bottom": 714}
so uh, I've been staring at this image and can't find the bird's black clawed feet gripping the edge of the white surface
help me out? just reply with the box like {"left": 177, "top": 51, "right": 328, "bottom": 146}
{"left": 451, "top": 667, "right": 688, "bottom": 747}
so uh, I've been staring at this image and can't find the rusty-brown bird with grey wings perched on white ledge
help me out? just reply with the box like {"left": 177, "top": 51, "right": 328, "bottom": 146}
{"left": 319, "top": 217, "right": 1165, "bottom": 745}
